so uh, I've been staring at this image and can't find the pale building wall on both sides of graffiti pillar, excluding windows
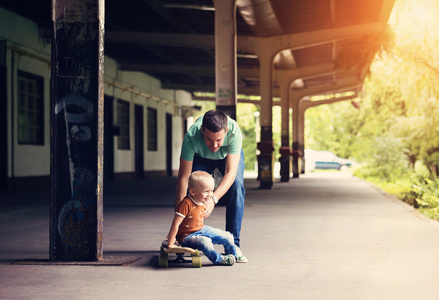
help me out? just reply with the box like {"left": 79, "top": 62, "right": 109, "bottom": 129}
{"left": 0, "top": 8, "right": 192, "bottom": 177}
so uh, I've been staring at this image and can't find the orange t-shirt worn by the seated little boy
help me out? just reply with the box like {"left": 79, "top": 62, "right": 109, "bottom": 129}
{"left": 175, "top": 196, "right": 206, "bottom": 243}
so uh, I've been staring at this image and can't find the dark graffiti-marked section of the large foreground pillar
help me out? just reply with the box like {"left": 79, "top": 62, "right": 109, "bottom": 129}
{"left": 51, "top": 22, "right": 99, "bottom": 260}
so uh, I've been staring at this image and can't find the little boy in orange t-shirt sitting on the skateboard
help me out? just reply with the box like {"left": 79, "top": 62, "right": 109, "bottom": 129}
{"left": 168, "top": 171, "right": 247, "bottom": 266}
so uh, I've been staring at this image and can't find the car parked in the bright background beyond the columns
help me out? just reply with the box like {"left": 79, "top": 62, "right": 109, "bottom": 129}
{"left": 305, "top": 149, "right": 354, "bottom": 171}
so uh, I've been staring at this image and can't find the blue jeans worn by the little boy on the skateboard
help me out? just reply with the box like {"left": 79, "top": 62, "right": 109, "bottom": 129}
{"left": 181, "top": 225, "right": 236, "bottom": 264}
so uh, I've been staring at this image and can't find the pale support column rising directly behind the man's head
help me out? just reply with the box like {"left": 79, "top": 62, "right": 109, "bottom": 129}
{"left": 214, "top": 0, "right": 237, "bottom": 120}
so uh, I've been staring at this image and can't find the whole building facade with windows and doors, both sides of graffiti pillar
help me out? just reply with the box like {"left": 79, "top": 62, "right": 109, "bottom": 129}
{"left": 0, "top": 8, "right": 192, "bottom": 189}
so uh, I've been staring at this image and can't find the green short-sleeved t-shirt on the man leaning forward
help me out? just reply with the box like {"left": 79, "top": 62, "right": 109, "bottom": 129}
{"left": 181, "top": 116, "right": 242, "bottom": 161}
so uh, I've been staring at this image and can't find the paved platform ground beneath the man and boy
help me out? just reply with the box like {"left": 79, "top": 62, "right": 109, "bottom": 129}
{"left": 0, "top": 172, "right": 439, "bottom": 299}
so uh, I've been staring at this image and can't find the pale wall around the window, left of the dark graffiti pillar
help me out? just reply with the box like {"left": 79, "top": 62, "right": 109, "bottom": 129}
{"left": 0, "top": 8, "right": 50, "bottom": 177}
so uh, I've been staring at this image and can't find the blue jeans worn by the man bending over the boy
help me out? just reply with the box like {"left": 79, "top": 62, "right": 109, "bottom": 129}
{"left": 192, "top": 149, "right": 245, "bottom": 247}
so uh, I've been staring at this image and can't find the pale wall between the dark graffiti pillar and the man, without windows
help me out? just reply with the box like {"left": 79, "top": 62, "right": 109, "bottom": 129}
{"left": 105, "top": 64, "right": 192, "bottom": 172}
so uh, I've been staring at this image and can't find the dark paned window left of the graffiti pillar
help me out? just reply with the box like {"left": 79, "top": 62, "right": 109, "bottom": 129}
{"left": 17, "top": 71, "right": 44, "bottom": 145}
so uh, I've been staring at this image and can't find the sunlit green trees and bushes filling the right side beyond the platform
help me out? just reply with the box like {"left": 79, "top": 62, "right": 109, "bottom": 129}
{"left": 305, "top": 0, "right": 439, "bottom": 219}
